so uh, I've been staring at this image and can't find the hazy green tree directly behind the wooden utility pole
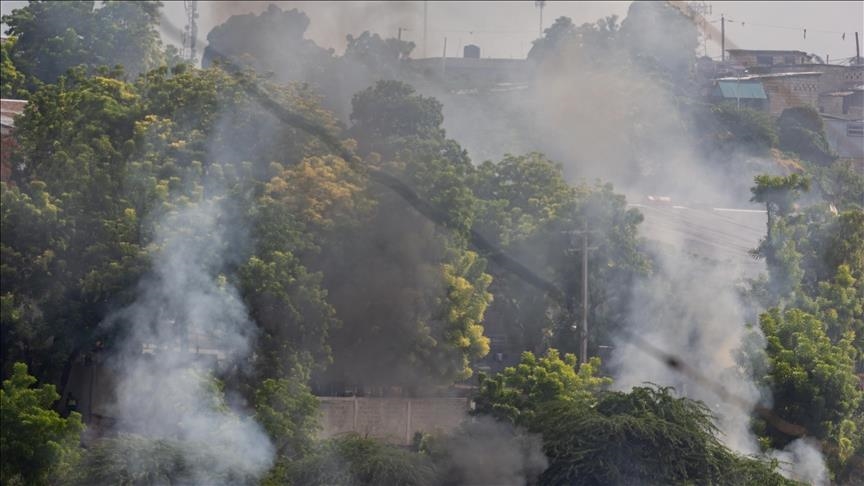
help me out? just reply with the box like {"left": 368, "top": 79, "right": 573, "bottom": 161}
{"left": 474, "top": 154, "right": 650, "bottom": 353}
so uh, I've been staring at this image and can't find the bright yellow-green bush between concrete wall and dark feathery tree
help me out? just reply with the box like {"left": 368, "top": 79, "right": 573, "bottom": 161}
{"left": 474, "top": 349, "right": 612, "bottom": 426}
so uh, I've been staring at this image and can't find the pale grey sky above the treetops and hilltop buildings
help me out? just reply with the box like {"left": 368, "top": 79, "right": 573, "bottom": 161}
{"left": 2, "top": 0, "right": 864, "bottom": 60}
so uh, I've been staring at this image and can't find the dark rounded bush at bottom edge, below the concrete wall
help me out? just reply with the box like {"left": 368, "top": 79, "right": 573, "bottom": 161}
{"left": 285, "top": 435, "right": 436, "bottom": 486}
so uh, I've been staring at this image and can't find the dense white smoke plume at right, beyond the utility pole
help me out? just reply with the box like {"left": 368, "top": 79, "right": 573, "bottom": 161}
{"left": 612, "top": 240, "right": 761, "bottom": 454}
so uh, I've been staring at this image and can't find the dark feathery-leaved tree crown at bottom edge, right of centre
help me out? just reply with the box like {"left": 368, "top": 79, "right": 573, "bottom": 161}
{"left": 535, "top": 387, "right": 794, "bottom": 485}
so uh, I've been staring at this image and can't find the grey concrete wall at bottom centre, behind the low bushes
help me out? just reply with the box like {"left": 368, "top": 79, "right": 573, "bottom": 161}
{"left": 318, "top": 397, "right": 469, "bottom": 445}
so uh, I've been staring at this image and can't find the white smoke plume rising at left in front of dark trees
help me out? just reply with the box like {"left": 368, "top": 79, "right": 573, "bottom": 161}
{"left": 108, "top": 200, "right": 273, "bottom": 484}
